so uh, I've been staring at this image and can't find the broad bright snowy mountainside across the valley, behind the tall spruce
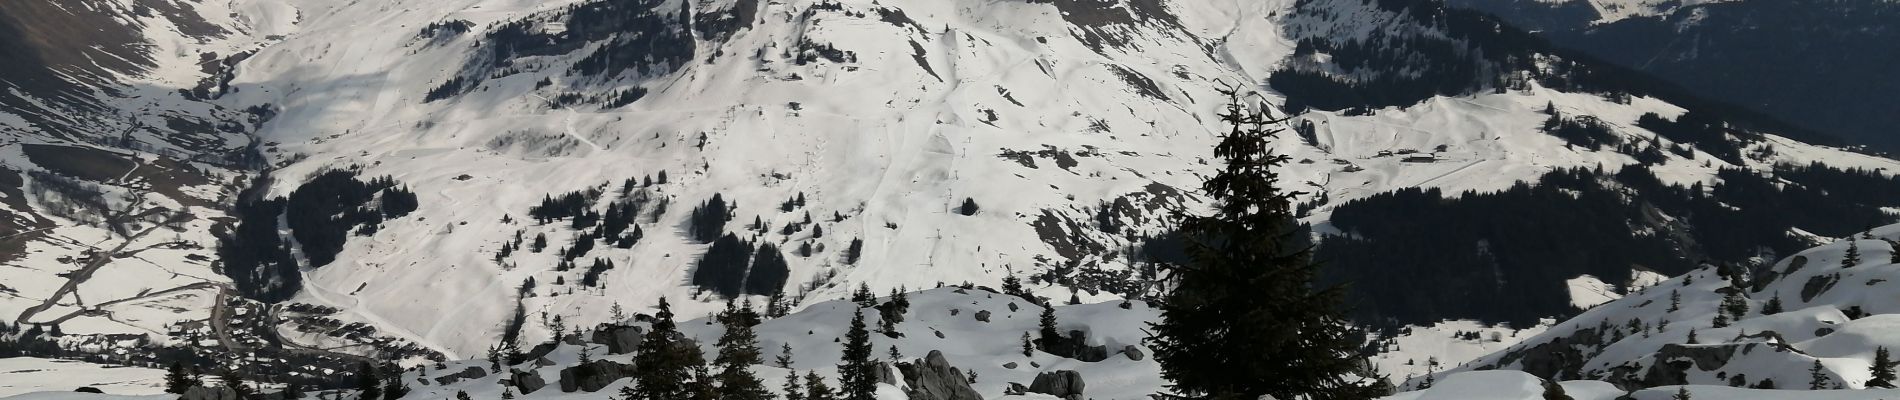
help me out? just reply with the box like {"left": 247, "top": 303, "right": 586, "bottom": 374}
{"left": 171, "top": 0, "right": 1894, "bottom": 360}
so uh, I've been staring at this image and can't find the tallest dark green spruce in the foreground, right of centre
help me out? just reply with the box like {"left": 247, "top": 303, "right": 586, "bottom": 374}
{"left": 1148, "top": 89, "right": 1381, "bottom": 400}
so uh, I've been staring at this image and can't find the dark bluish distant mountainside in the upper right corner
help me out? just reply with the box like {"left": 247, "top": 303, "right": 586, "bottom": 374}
{"left": 1452, "top": 0, "right": 1900, "bottom": 152}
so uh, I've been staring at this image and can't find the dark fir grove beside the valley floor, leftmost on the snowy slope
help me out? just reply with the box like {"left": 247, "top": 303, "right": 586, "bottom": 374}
{"left": 219, "top": 171, "right": 420, "bottom": 303}
